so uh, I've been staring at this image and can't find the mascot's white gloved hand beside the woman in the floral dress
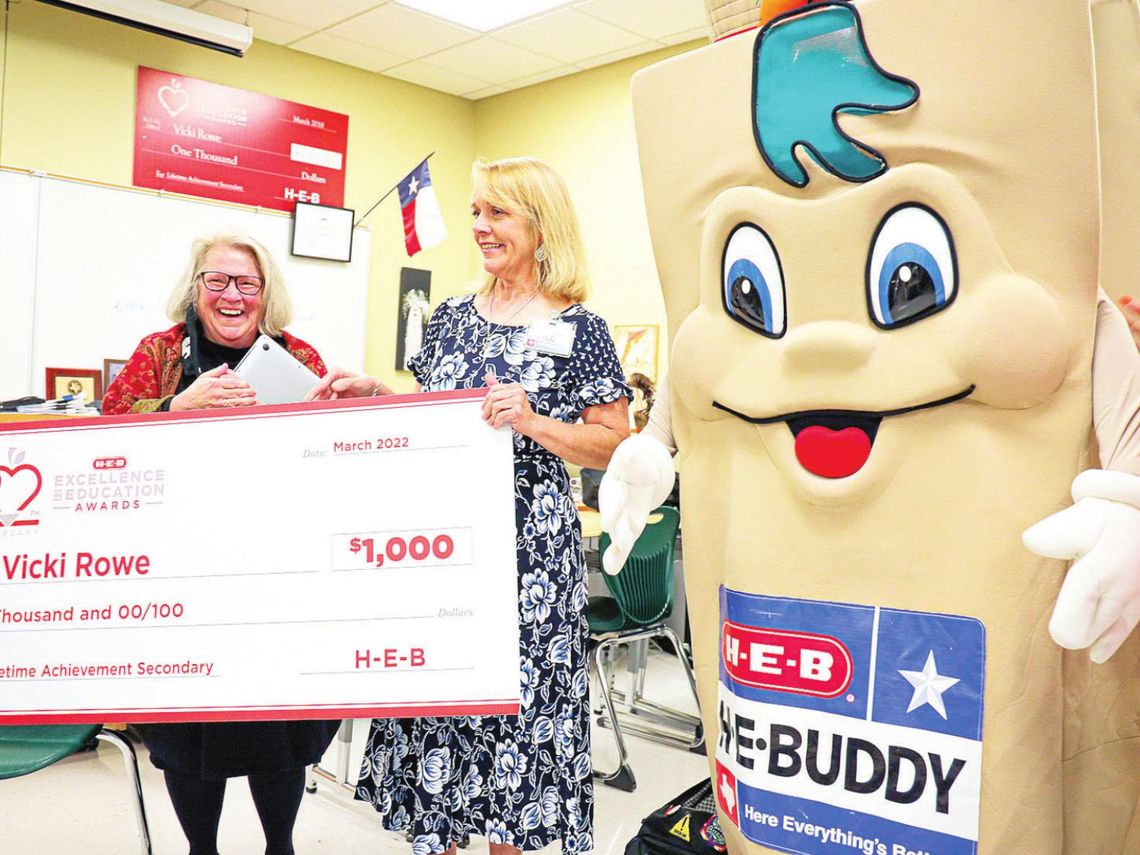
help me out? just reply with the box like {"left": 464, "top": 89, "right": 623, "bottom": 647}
{"left": 597, "top": 433, "right": 674, "bottom": 576}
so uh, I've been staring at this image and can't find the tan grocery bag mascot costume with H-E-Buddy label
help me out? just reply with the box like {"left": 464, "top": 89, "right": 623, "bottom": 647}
{"left": 602, "top": 0, "right": 1140, "bottom": 855}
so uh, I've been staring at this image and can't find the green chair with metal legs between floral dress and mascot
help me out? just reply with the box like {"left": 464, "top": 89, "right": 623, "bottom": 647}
{"left": 586, "top": 506, "right": 705, "bottom": 792}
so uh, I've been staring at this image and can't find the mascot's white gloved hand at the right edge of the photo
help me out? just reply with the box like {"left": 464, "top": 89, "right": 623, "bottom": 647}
{"left": 1021, "top": 470, "right": 1140, "bottom": 662}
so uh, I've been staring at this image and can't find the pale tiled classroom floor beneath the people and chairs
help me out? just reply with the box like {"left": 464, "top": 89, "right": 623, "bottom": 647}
{"left": 0, "top": 653, "right": 708, "bottom": 855}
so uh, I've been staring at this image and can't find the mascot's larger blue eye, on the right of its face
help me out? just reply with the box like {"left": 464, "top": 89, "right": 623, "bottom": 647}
{"left": 866, "top": 204, "right": 958, "bottom": 329}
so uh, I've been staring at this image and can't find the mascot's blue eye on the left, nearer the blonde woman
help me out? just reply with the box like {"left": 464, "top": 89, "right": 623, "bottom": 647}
{"left": 720, "top": 222, "right": 788, "bottom": 339}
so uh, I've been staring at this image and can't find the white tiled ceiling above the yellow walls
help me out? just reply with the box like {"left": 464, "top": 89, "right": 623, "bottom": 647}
{"left": 170, "top": 0, "right": 709, "bottom": 99}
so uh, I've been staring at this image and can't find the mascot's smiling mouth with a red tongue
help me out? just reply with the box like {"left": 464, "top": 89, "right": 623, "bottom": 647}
{"left": 713, "top": 384, "right": 975, "bottom": 478}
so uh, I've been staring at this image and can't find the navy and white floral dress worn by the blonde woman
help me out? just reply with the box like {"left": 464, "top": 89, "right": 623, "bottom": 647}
{"left": 356, "top": 296, "right": 630, "bottom": 855}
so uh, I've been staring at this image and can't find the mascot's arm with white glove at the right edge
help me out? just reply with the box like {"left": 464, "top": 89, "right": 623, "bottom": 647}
{"left": 1023, "top": 295, "right": 1140, "bottom": 662}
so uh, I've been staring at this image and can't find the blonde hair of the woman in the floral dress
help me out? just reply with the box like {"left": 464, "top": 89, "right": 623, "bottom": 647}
{"left": 471, "top": 157, "right": 589, "bottom": 303}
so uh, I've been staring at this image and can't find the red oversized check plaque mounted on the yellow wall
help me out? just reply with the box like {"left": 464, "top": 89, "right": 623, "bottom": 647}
{"left": 135, "top": 65, "right": 349, "bottom": 211}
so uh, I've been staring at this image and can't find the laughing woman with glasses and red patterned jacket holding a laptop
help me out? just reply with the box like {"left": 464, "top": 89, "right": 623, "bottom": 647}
{"left": 103, "top": 234, "right": 340, "bottom": 855}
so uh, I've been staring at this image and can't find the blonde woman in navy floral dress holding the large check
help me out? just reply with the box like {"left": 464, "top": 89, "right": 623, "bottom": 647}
{"left": 316, "top": 157, "right": 630, "bottom": 855}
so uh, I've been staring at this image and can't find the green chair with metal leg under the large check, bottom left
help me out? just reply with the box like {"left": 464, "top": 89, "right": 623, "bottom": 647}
{"left": 0, "top": 724, "right": 152, "bottom": 855}
